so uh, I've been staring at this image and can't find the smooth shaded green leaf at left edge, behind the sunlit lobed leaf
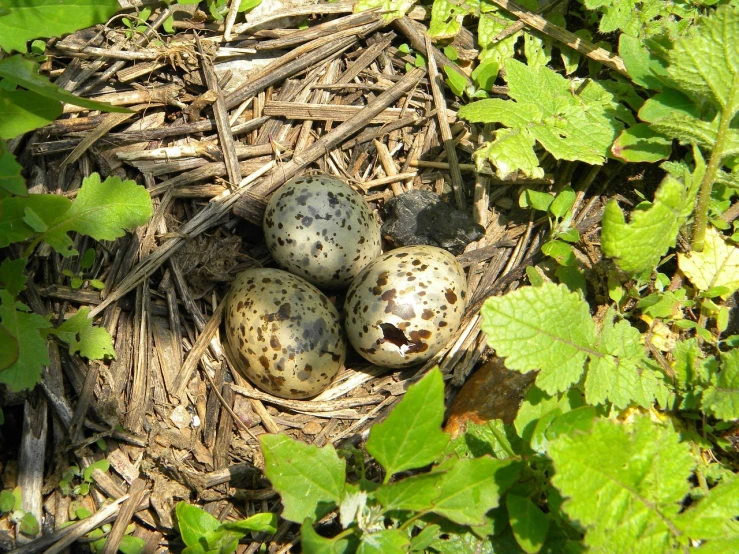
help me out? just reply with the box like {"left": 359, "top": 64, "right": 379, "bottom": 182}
{"left": 0, "top": 194, "right": 72, "bottom": 248}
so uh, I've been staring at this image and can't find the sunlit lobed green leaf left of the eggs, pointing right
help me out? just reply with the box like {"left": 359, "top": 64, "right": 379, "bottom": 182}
{"left": 44, "top": 173, "right": 153, "bottom": 256}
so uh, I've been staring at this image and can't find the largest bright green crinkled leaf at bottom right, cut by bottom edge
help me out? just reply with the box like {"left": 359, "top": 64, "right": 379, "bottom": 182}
{"left": 549, "top": 416, "right": 695, "bottom": 554}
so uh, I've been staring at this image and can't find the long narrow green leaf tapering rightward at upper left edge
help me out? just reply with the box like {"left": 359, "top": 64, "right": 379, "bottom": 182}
{"left": 0, "top": 56, "right": 131, "bottom": 113}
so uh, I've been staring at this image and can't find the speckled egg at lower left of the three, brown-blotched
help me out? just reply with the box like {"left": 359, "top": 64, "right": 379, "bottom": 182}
{"left": 225, "top": 268, "right": 346, "bottom": 398}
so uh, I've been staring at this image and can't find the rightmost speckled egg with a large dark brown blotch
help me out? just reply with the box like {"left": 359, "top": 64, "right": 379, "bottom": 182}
{"left": 344, "top": 246, "right": 467, "bottom": 368}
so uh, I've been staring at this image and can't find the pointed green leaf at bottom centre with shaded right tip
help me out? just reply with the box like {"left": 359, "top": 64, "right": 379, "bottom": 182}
{"left": 432, "top": 457, "right": 521, "bottom": 525}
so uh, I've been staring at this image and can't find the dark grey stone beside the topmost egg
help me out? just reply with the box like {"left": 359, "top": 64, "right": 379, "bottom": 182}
{"left": 382, "top": 190, "right": 485, "bottom": 252}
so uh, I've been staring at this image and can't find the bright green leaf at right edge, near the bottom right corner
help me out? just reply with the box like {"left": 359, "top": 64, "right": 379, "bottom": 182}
{"left": 677, "top": 475, "right": 739, "bottom": 540}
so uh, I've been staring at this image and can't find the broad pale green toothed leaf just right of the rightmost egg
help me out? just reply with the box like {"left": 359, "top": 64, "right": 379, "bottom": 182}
{"left": 481, "top": 283, "right": 596, "bottom": 394}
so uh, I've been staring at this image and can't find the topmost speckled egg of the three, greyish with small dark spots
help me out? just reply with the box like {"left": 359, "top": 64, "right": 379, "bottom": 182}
{"left": 263, "top": 175, "right": 382, "bottom": 288}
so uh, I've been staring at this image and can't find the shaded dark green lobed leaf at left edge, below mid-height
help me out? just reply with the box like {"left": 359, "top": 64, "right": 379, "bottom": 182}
{"left": 0, "top": 289, "right": 51, "bottom": 392}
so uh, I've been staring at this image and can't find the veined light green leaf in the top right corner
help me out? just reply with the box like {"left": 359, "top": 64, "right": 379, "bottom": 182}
{"left": 667, "top": 6, "right": 739, "bottom": 117}
